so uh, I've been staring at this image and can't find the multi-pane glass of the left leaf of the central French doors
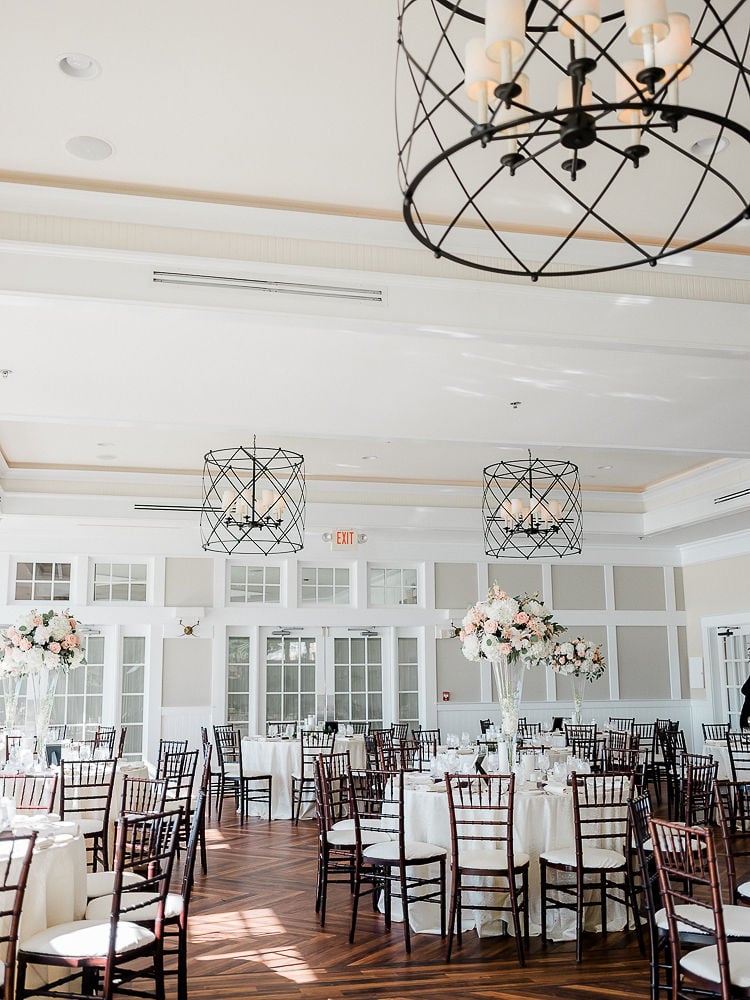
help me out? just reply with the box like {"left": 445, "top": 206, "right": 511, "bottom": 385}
{"left": 266, "top": 636, "right": 317, "bottom": 722}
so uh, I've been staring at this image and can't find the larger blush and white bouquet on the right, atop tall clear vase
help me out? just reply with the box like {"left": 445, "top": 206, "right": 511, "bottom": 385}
{"left": 458, "top": 583, "right": 565, "bottom": 667}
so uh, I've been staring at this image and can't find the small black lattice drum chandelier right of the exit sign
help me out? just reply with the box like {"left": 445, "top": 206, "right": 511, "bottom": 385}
{"left": 482, "top": 452, "right": 583, "bottom": 559}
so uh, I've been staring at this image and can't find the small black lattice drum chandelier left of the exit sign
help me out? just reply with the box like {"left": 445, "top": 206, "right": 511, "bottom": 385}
{"left": 200, "top": 438, "right": 305, "bottom": 556}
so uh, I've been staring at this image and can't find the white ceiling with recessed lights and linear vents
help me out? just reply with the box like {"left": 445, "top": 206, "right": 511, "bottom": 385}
{"left": 0, "top": 0, "right": 750, "bottom": 537}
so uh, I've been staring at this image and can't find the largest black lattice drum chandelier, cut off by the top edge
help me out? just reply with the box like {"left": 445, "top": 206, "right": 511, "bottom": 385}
{"left": 396, "top": 0, "right": 750, "bottom": 281}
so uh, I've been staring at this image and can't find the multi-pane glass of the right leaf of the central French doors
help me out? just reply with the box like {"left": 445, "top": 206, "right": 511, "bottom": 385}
{"left": 333, "top": 636, "right": 383, "bottom": 729}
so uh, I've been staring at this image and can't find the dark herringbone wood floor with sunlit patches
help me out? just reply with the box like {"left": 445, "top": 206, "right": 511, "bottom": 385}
{"left": 182, "top": 810, "right": 649, "bottom": 1000}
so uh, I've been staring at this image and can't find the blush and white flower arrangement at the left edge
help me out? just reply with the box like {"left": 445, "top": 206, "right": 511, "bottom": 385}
{"left": 0, "top": 610, "right": 86, "bottom": 678}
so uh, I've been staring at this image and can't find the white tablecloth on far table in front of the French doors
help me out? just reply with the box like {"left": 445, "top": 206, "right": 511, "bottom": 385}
{"left": 242, "top": 736, "right": 367, "bottom": 819}
